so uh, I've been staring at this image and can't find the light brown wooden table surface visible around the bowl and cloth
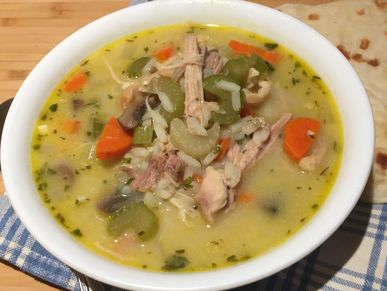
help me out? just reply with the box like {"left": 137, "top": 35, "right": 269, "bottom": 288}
{"left": 0, "top": 0, "right": 330, "bottom": 291}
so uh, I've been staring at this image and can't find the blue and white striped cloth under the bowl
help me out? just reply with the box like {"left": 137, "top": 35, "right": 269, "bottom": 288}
{"left": 0, "top": 196, "right": 387, "bottom": 291}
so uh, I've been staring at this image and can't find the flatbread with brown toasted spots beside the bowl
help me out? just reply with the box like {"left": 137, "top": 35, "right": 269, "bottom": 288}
{"left": 277, "top": 0, "right": 387, "bottom": 203}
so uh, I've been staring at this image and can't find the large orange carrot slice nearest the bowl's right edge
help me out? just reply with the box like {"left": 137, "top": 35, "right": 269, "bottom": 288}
{"left": 283, "top": 117, "right": 320, "bottom": 161}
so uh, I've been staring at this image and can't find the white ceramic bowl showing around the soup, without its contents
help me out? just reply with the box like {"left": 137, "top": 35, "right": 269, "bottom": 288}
{"left": 1, "top": 0, "right": 374, "bottom": 290}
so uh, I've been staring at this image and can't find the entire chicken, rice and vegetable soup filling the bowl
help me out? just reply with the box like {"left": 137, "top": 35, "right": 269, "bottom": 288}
{"left": 31, "top": 24, "right": 343, "bottom": 271}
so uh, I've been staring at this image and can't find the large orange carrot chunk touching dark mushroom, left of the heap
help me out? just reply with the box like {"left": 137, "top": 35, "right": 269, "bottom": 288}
{"left": 96, "top": 117, "right": 133, "bottom": 160}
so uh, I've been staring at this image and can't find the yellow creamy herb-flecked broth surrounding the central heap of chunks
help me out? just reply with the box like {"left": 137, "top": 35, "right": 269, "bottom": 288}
{"left": 31, "top": 24, "right": 343, "bottom": 271}
